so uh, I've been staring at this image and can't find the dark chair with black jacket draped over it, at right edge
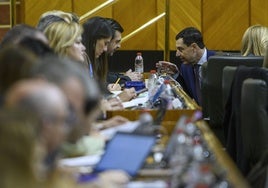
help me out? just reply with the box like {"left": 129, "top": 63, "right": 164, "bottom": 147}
{"left": 223, "top": 66, "right": 268, "bottom": 175}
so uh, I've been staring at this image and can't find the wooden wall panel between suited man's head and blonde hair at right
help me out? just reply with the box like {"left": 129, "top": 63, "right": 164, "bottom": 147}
{"left": 202, "top": 0, "right": 249, "bottom": 50}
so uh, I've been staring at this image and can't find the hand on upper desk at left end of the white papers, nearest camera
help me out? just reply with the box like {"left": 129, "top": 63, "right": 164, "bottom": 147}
{"left": 101, "top": 97, "right": 124, "bottom": 112}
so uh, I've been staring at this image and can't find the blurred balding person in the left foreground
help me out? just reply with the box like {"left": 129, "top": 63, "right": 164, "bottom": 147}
{"left": 5, "top": 80, "right": 80, "bottom": 188}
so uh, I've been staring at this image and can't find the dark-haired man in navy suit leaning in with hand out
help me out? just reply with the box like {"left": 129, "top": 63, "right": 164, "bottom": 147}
{"left": 156, "top": 27, "right": 215, "bottom": 105}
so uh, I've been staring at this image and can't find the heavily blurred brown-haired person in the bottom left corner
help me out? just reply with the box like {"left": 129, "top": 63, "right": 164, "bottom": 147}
{"left": 0, "top": 108, "right": 38, "bottom": 188}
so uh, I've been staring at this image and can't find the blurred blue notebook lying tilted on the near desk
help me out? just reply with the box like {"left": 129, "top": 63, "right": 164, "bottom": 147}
{"left": 94, "top": 132, "right": 156, "bottom": 177}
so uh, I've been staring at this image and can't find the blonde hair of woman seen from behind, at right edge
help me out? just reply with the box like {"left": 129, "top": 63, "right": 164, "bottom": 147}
{"left": 241, "top": 25, "right": 268, "bottom": 56}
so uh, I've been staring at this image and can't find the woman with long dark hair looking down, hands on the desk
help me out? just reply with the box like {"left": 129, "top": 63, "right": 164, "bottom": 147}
{"left": 82, "top": 16, "right": 136, "bottom": 101}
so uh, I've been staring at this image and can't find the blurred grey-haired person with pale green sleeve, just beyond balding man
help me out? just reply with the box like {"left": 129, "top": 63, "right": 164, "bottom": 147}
{"left": 33, "top": 57, "right": 128, "bottom": 156}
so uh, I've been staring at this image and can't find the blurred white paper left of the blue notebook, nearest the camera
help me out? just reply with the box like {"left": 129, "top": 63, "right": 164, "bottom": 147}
{"left": 59, "top": 155, "right": 101, "bottom": 167}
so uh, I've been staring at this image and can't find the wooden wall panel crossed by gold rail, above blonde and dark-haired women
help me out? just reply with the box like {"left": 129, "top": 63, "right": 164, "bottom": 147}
{"left": 73, "top": 0, "right": 113, "bottom": 17}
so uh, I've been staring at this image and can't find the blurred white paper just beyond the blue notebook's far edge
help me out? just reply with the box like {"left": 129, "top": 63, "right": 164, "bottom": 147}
{"left": 100, "top": 121, "right": 139, "bottom": 139}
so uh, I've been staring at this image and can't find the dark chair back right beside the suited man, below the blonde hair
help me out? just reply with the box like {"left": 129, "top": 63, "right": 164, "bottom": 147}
{"left": 201, "top": 56, "right": 263, "bottom": 128}
